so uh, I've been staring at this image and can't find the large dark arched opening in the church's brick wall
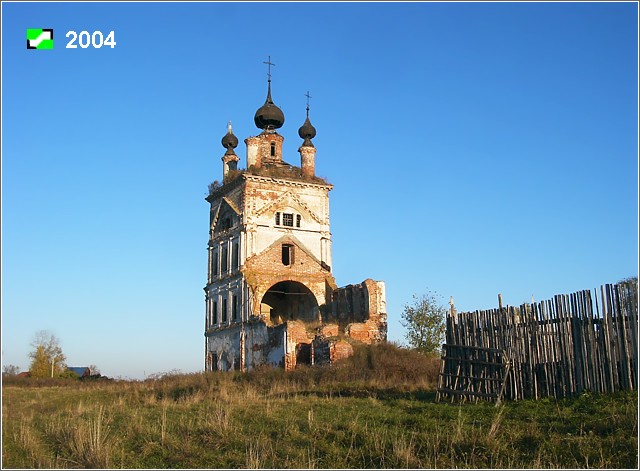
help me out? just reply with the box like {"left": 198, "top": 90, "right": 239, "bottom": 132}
{"left": 260, "top": 281, "right": 319, "bottom": 325}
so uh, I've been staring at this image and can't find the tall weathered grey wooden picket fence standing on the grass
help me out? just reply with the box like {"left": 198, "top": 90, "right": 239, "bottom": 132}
{"left": 437, "top": 280, "right": 638, "bottom": 401}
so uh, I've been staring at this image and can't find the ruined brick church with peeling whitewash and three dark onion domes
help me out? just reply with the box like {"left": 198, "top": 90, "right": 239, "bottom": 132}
{"left": 204, "top": 61, "right": 387, "bottom": 371}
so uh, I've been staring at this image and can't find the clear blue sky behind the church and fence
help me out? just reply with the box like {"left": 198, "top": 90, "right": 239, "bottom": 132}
{"left": 2, "top": 2, "right": 638, "bottom": 378}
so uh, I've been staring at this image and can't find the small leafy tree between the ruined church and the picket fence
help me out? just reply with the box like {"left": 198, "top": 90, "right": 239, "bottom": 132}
{"left": 401, "top": 291, "right": 447, "bottom": 354}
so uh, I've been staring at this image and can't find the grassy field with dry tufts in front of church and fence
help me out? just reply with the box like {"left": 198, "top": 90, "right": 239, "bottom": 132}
{"left": 2, "top": 345, "right": 638, "bottom": 469}
